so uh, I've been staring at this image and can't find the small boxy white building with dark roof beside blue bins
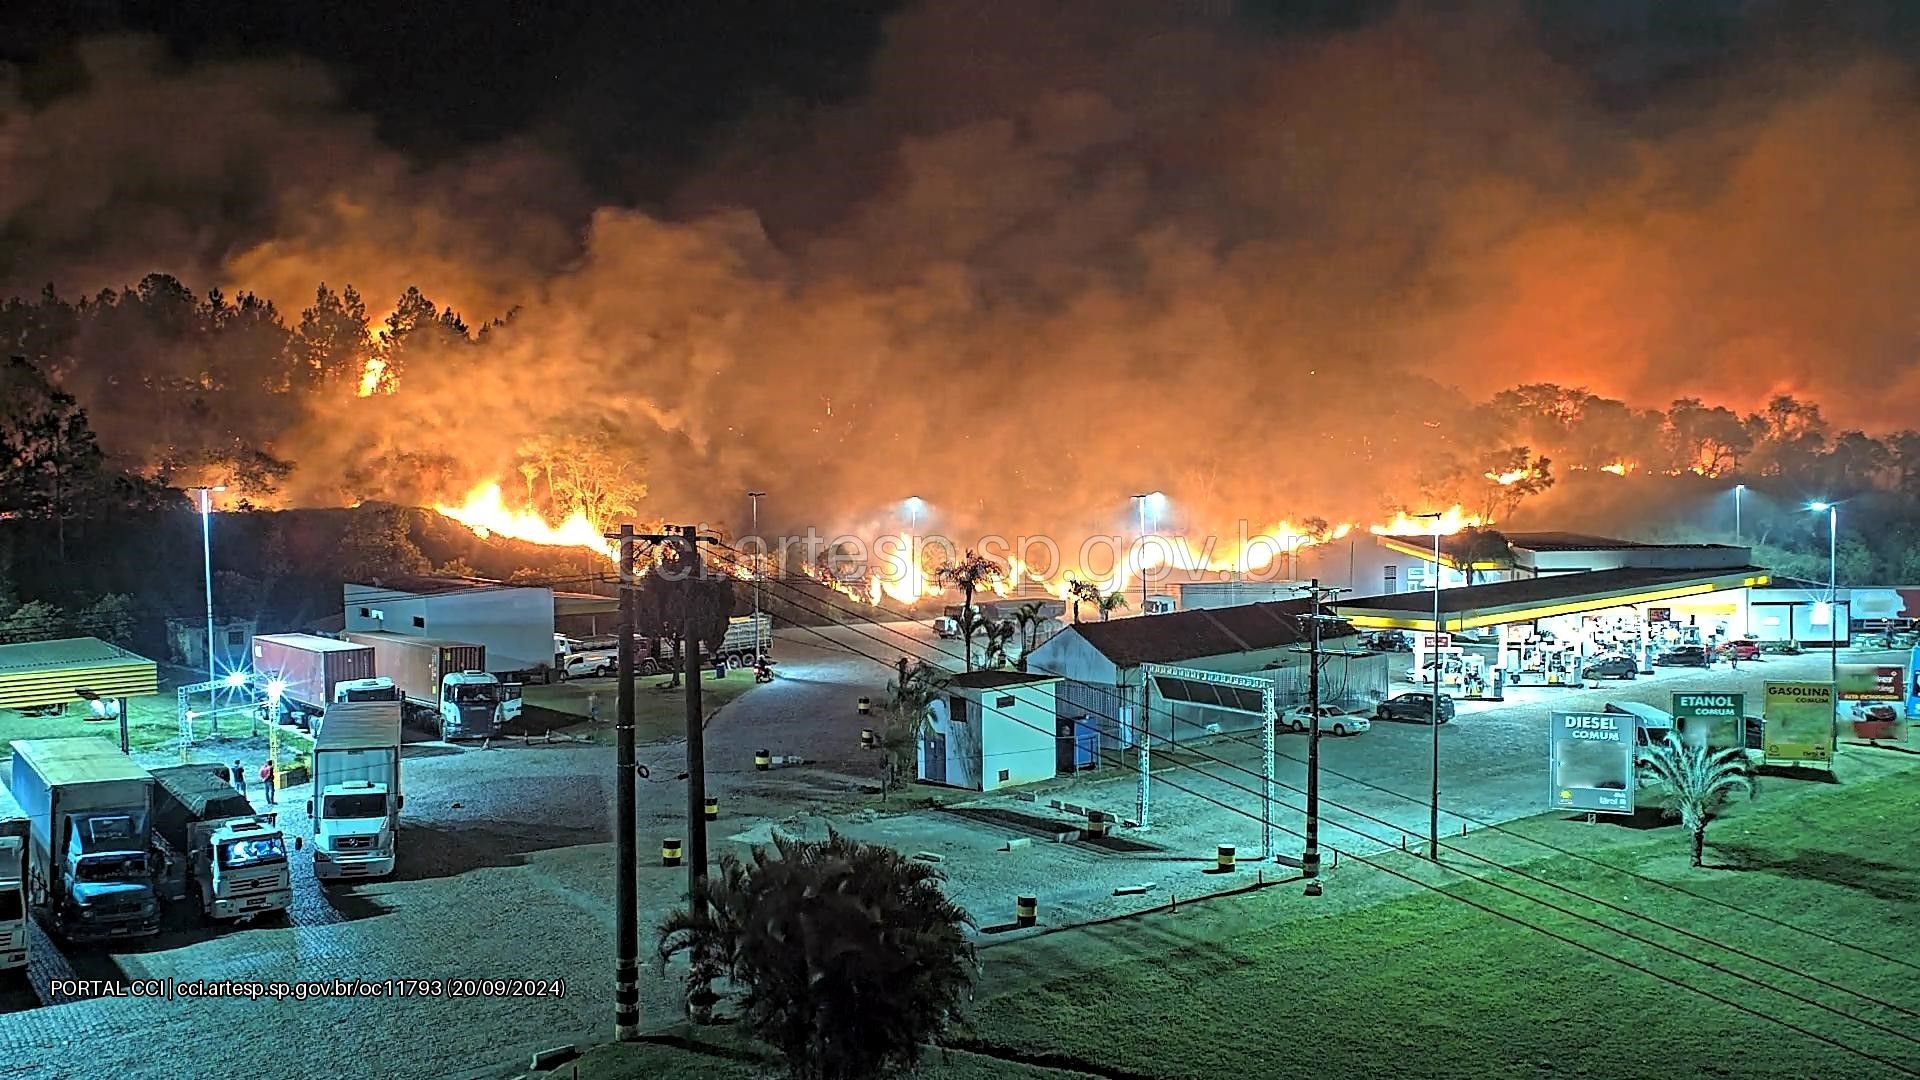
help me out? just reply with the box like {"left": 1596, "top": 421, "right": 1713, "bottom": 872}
{"left": 920, "top": 671, "right": 1060, "bottom": 792}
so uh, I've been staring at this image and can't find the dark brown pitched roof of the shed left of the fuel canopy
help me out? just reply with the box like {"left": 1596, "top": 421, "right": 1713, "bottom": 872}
{"left": 1066, "top": 598, "right": 1354, "bottom": 667}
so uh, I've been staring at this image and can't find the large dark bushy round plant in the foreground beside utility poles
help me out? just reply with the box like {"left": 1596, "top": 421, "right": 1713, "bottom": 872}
{"left": 657, "top": 830, "right": 977, "bottom": 1080}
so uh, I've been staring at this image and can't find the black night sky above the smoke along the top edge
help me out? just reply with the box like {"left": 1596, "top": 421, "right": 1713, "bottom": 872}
{"left": 0, "top": 0, "right": 1920, "bottom": 198}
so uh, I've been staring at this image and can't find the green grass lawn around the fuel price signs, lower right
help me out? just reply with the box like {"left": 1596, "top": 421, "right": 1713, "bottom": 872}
{"left": 975, "top": 760, "right": 1920, "bottom": 1080}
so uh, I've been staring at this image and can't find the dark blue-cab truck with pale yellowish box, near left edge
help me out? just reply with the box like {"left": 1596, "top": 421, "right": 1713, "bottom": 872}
{"left": 13, "top": 736, "right": 159, "bottom": 942}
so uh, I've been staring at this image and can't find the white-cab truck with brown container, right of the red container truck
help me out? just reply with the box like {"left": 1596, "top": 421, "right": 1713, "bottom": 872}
{"left": 348, "top": 630, "right": 503, "bottom": 740}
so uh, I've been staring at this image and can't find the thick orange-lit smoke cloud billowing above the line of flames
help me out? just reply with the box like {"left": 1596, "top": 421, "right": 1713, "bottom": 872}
{"left": 0, "top": 0, "right": 1920, "bottom": 536}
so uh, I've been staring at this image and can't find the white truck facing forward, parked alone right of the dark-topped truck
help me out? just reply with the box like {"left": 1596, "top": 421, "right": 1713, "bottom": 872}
{"left": 307, "top": 701, "right": 405, "bottom": 880}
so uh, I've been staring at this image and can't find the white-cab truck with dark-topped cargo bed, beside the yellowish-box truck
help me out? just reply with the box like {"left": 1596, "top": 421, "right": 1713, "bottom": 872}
{"left": 154, "top": 763, "right": 294, "bottom": 920}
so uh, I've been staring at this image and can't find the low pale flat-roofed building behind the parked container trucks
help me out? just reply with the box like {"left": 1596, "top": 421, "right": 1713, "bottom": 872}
{"left": 344, "top": 577, "right": 553, "bottom": 675}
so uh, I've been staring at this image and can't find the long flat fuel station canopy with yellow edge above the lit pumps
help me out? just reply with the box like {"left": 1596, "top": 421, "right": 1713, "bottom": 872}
{"left": 1332, "top": 567, "right": 1772, "bottom": 632}
